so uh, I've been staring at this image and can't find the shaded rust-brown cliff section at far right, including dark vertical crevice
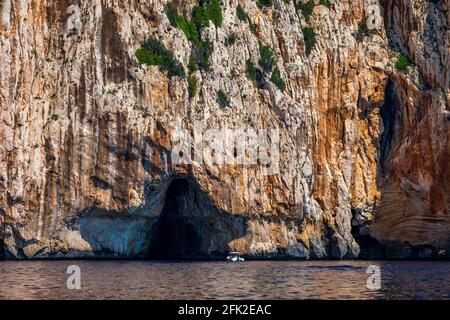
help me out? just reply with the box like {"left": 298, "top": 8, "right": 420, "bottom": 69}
{"left": 374, "top": 1, "right": 450, "bottom": 257}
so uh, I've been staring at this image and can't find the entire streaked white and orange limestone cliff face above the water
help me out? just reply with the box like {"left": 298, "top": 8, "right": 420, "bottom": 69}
{"left": 0, "top": 0, "right": 450, "bottom": 259}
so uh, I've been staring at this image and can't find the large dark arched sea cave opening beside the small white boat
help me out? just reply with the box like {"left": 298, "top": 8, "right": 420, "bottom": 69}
{"left": 148, "top": 177, "right": 246, "bottom": 260}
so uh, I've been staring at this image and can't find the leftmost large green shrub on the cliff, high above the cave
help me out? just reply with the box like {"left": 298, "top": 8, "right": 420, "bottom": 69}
{"left": 135, "top": 38, "right": 185, "bottom": 78}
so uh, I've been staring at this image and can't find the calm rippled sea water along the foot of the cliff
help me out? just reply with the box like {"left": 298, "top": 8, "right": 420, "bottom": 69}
{"left": 0, "top": 261, "right": 450, "bottom": 299}
